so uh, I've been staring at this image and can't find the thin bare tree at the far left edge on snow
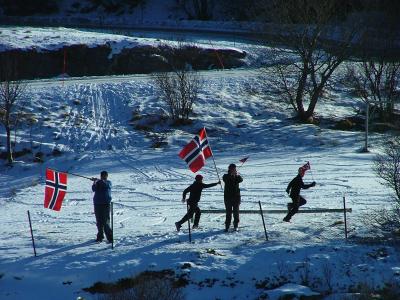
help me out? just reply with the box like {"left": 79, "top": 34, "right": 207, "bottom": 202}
{"left": 0, "top": 57, "right": 26, "bottom": 164}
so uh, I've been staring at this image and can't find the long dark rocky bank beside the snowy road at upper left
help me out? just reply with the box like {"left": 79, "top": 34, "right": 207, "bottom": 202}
{"left": 0, "top": 45, "right": 246, "bottom": 79}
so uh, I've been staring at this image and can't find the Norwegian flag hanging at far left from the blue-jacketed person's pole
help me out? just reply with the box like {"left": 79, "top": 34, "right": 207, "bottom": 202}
{"left": 44, "top": 169, "right": 67, "bottom": 211}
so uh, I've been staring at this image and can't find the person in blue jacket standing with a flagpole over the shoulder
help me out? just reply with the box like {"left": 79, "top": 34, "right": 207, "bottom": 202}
{"left": 92, "top": 171, "right": 113, "bottom": 243}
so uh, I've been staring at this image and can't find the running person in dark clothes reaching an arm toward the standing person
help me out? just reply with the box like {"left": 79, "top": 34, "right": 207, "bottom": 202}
{"left": 175, "top": 174, "right": 220, "bottom": 231}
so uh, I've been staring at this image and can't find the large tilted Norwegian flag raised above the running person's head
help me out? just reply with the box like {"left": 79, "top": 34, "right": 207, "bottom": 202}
{"left": 179, "top": 128, "right": 213, "bottom": 173}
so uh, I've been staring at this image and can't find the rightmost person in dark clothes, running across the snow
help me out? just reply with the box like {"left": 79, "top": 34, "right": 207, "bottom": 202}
{"left": 283, "top": 167, "right": 315, "bottom": 222}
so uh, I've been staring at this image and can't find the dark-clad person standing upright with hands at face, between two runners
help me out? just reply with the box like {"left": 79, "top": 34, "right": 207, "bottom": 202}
{"left": 222, "top": 164, "right": 243, "bottom": 232}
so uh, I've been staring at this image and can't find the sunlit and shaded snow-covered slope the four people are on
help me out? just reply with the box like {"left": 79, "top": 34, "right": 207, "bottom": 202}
{"left": 0, "top": 27, "right": 400, "bottom": 299}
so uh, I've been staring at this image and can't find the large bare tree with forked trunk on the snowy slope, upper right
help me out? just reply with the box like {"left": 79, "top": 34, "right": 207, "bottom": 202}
{"left": 260, "top": 0, "right": 354, "bottom": 121}
